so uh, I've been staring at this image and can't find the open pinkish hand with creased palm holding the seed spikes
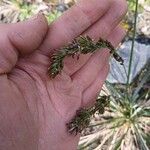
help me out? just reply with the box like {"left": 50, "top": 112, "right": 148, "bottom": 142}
{"left": 0, "top": 0, "right": 127, "bottom": 150}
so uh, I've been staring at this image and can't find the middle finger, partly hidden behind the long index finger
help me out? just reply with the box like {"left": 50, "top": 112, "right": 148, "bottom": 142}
{"left": 84, "top": 0, "right": 127, "bottom": 39}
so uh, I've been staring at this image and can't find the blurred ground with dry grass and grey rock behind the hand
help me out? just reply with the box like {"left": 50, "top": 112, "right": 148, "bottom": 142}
{"left": 0, "top": 0, "right": 150, "bottom": 150}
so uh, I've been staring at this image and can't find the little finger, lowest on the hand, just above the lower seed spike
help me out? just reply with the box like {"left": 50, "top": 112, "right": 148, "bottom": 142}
{"left": 82, "top": 64, "right": 109, "bottom": 107}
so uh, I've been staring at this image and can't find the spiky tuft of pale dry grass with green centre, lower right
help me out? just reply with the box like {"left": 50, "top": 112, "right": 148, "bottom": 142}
{"left": 79, "top": 61, "right": 150, "bottom": 150}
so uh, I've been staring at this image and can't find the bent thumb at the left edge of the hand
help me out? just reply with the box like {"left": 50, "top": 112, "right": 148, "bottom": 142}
{"left": 0, "top": 14, "right": 48, "bottom": 74}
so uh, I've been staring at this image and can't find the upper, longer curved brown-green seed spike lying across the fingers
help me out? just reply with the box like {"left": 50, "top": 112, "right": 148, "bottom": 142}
{"left": 48, "top": 36, "right": 123, "bottom": 78}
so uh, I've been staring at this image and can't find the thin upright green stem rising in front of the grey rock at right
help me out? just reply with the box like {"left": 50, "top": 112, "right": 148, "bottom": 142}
{"left": 126, "top": 0, "right": 138, "bottom": 97}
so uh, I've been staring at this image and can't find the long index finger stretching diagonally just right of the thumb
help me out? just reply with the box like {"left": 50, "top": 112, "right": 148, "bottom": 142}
{"left": 40, "top": 0, "right": 112, "bottom": 55}
